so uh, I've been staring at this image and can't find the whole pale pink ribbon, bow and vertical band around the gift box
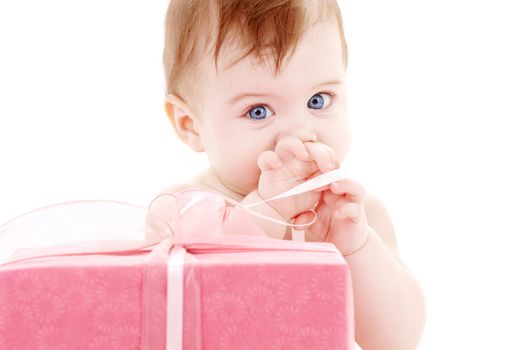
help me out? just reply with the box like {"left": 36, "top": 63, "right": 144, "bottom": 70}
{"left": 0, "top": 169, "right": 344, "bottom": 350}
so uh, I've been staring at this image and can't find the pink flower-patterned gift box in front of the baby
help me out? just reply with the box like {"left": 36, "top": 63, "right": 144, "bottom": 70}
{"left": 0, "top": 187, "right": 354, "bottom": 350}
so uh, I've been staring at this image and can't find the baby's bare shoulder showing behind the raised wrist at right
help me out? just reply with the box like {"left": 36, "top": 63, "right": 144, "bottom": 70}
{"left": 364, "top": 194, "right": 401, "bottom": 261}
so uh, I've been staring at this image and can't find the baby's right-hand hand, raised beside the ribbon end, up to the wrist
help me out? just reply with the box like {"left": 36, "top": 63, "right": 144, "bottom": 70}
{"left": 294, "top": 179, "right": 368, "bottom": 255}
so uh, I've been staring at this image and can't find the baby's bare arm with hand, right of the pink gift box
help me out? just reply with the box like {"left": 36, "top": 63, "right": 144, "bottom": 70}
{"left": 295, "top": 179, "right": 425, "bottom": 350}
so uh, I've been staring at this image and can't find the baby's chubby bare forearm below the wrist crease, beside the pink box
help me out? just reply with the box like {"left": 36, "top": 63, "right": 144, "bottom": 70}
{"left": 345, "top": 227, "right": 426, "bottom": 350}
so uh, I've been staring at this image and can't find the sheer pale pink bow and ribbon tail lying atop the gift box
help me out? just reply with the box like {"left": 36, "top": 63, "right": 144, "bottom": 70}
{"left": 0, "top": 169, "right": 344, "bottom": 266}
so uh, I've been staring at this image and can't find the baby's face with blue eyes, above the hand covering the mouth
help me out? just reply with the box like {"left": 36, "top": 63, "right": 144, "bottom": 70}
{"left": 190, "top": 22, "right": 350, "bottom": 195}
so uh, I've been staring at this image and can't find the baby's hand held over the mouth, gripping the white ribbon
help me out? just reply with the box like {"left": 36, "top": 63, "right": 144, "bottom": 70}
{"left": 257, "top": 136, "right": 339, "bottom": 221}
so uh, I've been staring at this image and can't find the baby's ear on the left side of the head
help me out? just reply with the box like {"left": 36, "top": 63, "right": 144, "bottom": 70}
{"left": 164, "top": 95, "right": 204, "bottom": 152}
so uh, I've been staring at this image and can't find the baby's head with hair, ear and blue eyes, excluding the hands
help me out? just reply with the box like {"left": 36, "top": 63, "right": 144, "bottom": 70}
{"left": 164, "top": 0, "right": 350, "bottom": 195}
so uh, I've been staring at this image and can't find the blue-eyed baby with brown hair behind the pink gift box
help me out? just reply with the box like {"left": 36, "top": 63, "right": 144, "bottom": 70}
{"left": 156, "top": 0, "right": 425, "bottom": 350}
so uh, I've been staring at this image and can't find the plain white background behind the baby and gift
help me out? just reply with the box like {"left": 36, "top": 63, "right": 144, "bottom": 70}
{"left": 0, "top": 0, "right": 525, "bottom": 350}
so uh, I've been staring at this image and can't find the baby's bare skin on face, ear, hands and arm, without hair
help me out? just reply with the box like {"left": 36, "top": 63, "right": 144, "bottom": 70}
{"left": 157, "top": 10, "right": 425, "bottom": 350}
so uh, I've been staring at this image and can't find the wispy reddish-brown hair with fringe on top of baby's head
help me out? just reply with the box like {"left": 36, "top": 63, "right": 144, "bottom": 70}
{"left": 163, "top": 0, "right": 346, "bottom": 109}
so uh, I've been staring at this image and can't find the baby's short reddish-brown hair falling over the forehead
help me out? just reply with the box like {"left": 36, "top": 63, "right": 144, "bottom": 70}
{"left": 163, "top": 0, "right": 348, "bottom": 106}
